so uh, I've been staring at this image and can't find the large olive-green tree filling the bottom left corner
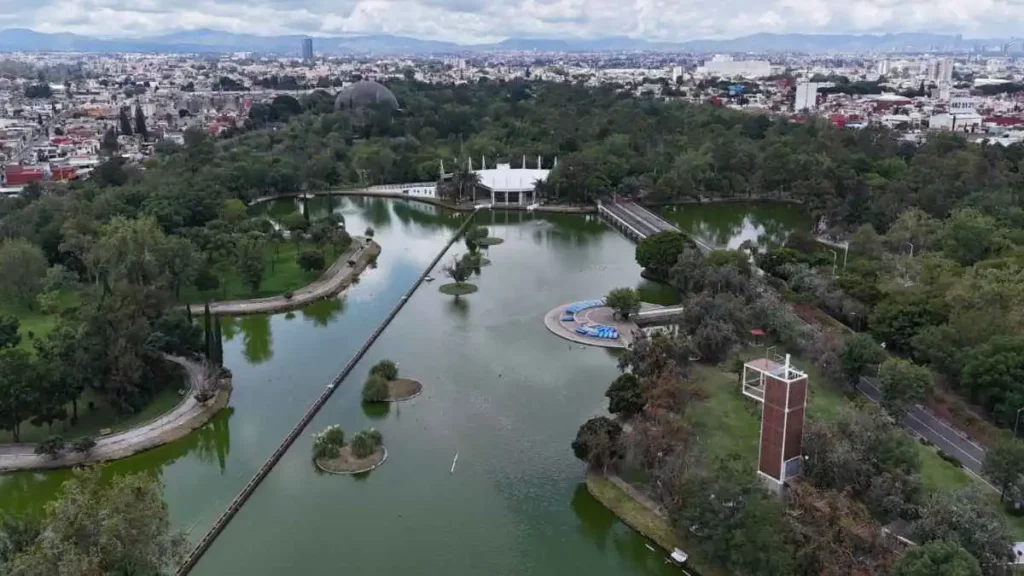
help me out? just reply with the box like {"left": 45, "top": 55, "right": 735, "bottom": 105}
{"left": 5, "top": 467, "right": 188, "bottom": 576}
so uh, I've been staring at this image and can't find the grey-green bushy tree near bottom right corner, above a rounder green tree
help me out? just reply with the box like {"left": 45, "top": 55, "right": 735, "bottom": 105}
{"left": 910, "top": 487, "right": 1013, "bottom": 573}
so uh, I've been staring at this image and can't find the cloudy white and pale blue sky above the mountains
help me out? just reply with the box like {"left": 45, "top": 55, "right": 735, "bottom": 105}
{"left": 0, "top": 0, "right": 1024, "bottom": 43}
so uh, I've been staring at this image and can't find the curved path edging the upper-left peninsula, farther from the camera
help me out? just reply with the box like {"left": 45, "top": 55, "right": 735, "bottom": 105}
{"left": 196, "top": 238, "right": 381, "bottom": 316}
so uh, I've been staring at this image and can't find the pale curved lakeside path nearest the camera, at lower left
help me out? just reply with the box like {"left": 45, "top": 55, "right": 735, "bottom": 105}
{"left": 0, "top": 355, "right": 228, "bottom": 472}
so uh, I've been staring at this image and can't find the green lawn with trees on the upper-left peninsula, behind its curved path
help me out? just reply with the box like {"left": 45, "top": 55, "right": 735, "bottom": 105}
{"left": 181, "top": 242, "right": 342, "bottom": 303}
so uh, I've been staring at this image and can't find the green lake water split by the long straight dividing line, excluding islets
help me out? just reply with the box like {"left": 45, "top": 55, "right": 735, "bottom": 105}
{"left": 0, "top": 198, "right": 807, "bottom": 575}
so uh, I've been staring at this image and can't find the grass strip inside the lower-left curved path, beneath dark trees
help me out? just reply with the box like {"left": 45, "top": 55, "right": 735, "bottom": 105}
{"left": 0, "top": 386, "right": 181, "bottom": 443}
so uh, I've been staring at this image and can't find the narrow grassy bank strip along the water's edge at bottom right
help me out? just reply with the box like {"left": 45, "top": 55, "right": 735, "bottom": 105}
{"left": 587, "top": 474, "right": 725, "bottom": 576}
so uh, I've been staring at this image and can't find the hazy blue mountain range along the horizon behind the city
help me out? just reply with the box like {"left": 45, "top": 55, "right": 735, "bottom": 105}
{"left": 0, "top": 29, "right": 1002, "bottom": 55}
